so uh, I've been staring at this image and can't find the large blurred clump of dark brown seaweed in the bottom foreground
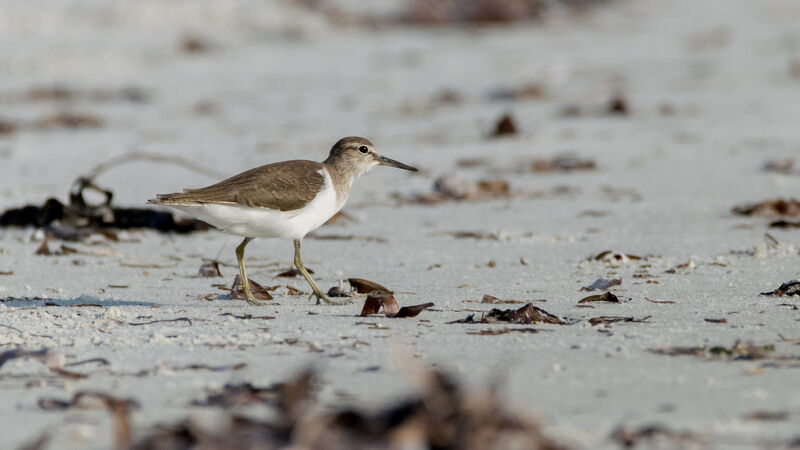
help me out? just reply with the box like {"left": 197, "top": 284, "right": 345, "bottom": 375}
{"left": 132, "top": 371, "right": 566, "bottom": 450}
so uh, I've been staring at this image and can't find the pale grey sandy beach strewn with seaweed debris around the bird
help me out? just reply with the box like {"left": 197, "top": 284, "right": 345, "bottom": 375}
{"left": 0, "top": 0, "right": 800, "bottom": 449}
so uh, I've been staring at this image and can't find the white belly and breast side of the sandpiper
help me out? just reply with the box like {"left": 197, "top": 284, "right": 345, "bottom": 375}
{"left": 169, "top": 173, "right": 341, "bottom": 239}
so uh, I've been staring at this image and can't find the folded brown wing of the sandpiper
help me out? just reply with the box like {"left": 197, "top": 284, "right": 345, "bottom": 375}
{"left": 150, "top": 160, "right": 325, "bottom": 211}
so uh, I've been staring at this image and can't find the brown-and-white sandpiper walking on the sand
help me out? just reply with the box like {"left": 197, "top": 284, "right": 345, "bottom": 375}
{"left": 148, "top": 137, "right": 417, "bottom": 305}
